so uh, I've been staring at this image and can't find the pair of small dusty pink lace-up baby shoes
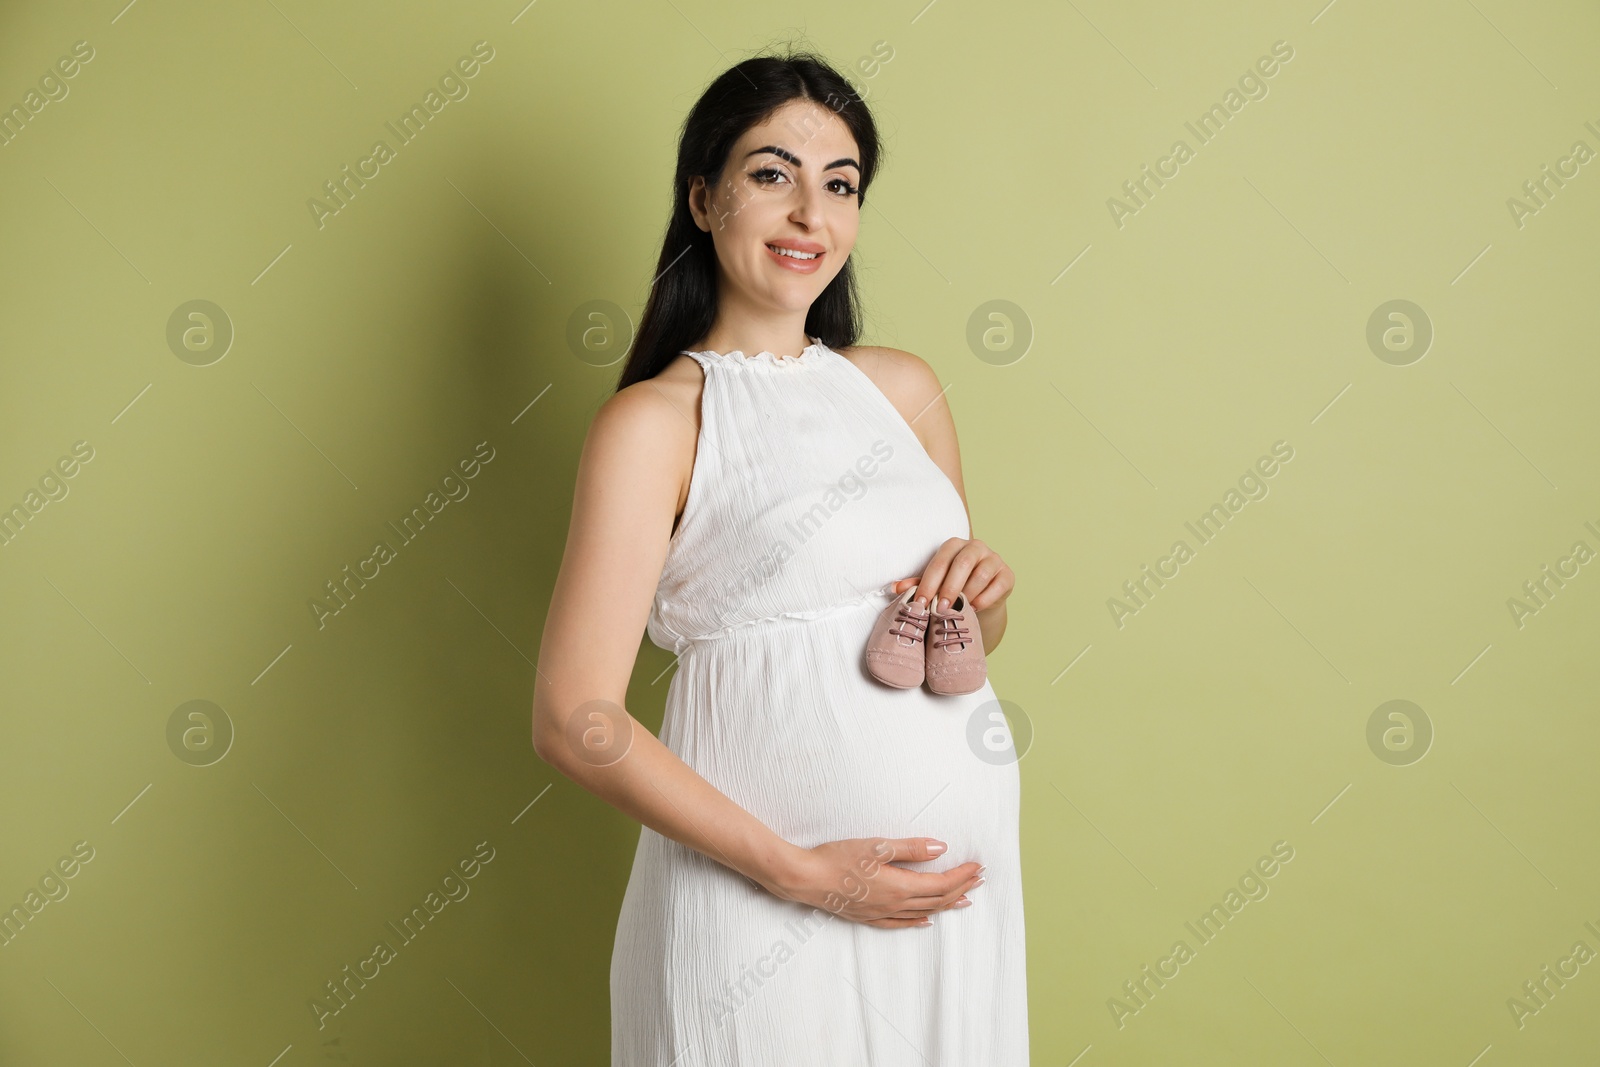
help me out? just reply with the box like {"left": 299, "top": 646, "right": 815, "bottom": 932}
{"left": 866, "top": 585, "right": 987, "bottom": 696}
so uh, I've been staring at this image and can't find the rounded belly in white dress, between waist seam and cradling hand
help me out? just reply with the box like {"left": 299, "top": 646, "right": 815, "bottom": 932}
{"left": 662, "top": 624, "right": 1019, "bottom": 870}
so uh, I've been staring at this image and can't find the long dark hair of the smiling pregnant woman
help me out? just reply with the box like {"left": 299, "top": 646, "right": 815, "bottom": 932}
{"left": 616, "top": 51, "right": 880, "bottom": 390}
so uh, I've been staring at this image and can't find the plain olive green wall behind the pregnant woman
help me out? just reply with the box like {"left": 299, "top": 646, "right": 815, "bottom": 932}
{"left": 0, "top": 0, "right": 1600, "bottom": 1067}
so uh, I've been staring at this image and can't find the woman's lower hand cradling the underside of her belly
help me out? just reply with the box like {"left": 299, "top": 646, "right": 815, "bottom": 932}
{"left": 765, "top": 837, "right": 984, "bottom": 928}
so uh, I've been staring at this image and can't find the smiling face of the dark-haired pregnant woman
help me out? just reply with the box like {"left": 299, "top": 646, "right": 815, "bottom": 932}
{"left": 690, "top": 99, "right": 861, "bottom": 312}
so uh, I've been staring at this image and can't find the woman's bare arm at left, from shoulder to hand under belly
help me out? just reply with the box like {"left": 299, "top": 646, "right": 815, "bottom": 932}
{"left": 533, "top": 382, "right": 976, "bottom": 926}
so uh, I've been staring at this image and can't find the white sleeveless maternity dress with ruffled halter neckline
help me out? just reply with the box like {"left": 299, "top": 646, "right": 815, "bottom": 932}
{"left": 611, "top": 338, "right": 1029, "bottom": 1067}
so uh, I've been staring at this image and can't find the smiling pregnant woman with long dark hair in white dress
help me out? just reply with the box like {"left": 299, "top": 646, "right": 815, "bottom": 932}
{"left": 533, "top": 47, "right": 1027, "bottom": 1067}
